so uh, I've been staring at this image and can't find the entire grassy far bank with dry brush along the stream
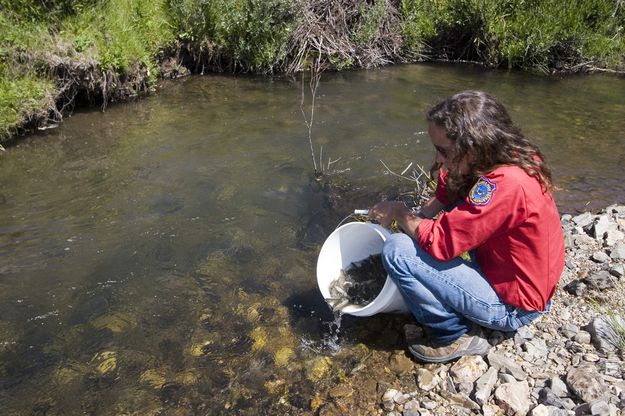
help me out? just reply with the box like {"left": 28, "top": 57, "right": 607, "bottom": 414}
{"left": 0, "top": 0, "right": 625, "bottom": 144}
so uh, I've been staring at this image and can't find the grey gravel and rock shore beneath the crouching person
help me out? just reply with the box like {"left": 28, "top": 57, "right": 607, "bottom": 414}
{"left": 311, "top": 205, "right": 625, "bottom": 416}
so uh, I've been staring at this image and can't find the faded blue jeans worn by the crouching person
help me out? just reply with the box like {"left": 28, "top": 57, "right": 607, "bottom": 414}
{"left": 382, "top": 233, "right": 550, "bottom": 345}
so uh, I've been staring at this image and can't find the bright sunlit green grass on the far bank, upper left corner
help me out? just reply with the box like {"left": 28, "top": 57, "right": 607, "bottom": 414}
{"left": 0, "top": 0, "right": 176, "bottom": 143}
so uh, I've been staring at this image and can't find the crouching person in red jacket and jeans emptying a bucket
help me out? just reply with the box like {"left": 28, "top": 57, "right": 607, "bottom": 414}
{"left": 369, "top": 91, "right": 564, "bottom": 363}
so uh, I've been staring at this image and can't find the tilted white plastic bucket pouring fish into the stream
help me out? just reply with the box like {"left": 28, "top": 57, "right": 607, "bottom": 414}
{"left": 317, "top": 222, "right": 408, "bottom": 316}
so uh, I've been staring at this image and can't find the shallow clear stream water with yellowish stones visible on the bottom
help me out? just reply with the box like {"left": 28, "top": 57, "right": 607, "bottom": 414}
{"left": 0, "top": 65, "right": 625, "bottom": 415}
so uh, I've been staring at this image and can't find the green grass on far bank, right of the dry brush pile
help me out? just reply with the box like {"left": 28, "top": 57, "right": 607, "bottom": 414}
{"left": 402, "top": 0, "right": 625, "bottom": 71}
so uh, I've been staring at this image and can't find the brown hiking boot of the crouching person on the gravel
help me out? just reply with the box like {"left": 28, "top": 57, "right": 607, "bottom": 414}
{"left": 408, "top": 326, "right": 490, "bottom": 363}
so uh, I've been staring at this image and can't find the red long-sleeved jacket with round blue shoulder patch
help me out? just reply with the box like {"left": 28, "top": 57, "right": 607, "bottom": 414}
{"left": 418, "top": 166, "right": 564, "bottom": 311}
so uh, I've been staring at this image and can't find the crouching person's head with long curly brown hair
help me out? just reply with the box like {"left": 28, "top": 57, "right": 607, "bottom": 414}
{"left": 427, "top": 91, "right": 554, "bottom": 199}
